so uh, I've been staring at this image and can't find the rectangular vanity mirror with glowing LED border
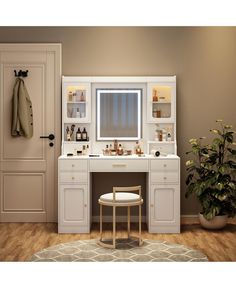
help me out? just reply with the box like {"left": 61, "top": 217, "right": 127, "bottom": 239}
{"left": 96, "top": 89, "right": 142, "bottom": 141}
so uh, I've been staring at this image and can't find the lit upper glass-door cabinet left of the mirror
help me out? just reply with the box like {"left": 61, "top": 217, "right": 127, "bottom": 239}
{"left": 62, "top": 77, "right": 91, "bottom": 124}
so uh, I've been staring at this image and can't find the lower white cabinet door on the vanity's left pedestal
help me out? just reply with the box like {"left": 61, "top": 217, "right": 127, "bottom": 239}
{"left": 59, "top": 185, "right": 88, "bottom": 226}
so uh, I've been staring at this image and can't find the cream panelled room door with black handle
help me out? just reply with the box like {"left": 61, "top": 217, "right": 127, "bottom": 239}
{"left": 0, "top": 44, "right": 61, "bottom": 222}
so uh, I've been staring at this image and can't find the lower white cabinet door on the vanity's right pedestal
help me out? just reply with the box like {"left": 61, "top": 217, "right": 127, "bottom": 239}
{"left": 149, "top": 185, "right": 180, "bottom": 228}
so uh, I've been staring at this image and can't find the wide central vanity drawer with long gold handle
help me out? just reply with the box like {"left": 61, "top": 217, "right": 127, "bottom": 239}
{"left": 90, "top": 159, "right": 148, "bottom": 172}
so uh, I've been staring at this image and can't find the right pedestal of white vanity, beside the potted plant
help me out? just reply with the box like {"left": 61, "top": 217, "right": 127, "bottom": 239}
{"left": 148, "top": 159, "right": 180, "bottom": 233}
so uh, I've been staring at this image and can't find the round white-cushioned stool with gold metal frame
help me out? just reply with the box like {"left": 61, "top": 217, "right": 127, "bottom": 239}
{"left": 98, "top": 186, "right": 143, "bottom": 248}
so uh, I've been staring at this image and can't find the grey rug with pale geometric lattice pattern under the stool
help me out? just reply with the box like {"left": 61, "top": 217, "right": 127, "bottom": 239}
{"left": 29, "top": 239, "right": 208, "bottom": 262}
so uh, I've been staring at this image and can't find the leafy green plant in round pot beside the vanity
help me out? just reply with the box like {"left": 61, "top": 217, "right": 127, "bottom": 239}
{"left": 185, "top": 120, "right": 236, "bottom": 229}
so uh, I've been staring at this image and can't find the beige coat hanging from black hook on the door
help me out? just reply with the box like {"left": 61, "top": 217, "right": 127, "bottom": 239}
{"left": 11, "top": 78, "right": 33, "bottom": 138}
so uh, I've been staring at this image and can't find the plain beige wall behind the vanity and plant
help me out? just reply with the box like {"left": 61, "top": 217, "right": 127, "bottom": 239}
{"left": 0, "top": 27, "right": 236, "bottom": 214}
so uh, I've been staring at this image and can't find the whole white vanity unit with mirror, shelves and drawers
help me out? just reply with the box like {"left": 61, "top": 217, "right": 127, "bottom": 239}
{"left": 58, "top": 76, "right": 180, "bottom": 233}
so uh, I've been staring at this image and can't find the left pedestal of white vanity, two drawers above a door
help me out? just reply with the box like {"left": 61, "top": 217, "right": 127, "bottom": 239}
{"left": 58, "top": 159, "right": 90, "bottom": 233}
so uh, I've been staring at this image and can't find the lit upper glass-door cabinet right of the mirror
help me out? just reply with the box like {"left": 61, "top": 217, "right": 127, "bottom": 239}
{"left": 147, "top": 81, "right": 176, "bottom": 123}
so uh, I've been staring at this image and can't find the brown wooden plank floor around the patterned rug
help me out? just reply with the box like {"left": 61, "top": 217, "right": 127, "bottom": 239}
{"left": 0, "top": 223, "right": 236, "bottom": 261}
